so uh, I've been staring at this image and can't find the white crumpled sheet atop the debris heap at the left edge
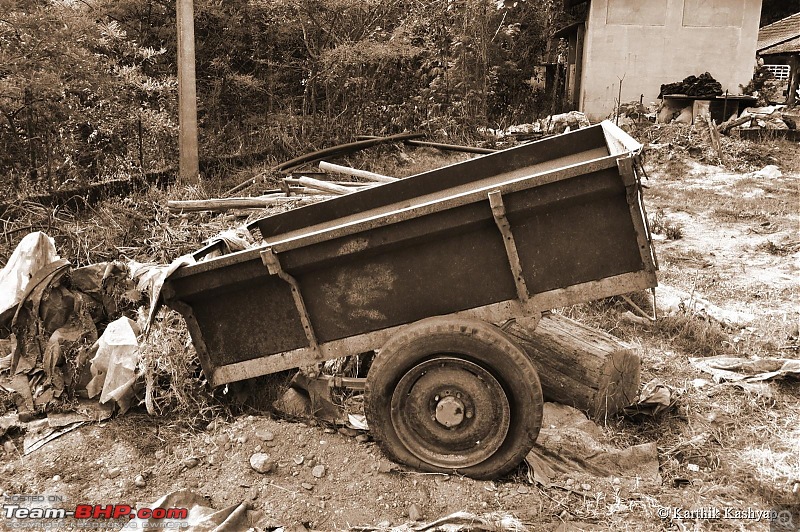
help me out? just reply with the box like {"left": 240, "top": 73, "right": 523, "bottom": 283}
{"left": 0, "top": 231, "right": 61, "bottom": 315}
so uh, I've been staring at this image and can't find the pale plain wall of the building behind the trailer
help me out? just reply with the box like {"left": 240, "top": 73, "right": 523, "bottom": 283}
{"left": 580, "top": 0, "right": 761, "bottom": 121}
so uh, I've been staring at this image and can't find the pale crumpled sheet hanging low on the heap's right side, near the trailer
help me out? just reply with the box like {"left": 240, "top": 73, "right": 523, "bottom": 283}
{"left": 86, "top": 317, "right": 140, "bottom": 413}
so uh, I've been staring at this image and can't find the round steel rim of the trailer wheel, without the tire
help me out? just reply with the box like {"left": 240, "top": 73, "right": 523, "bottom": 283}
{"left": 391, "top": 355, "right": 511, "bottom": 469}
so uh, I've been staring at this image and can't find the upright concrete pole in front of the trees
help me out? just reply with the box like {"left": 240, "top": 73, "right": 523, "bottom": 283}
{"left": 177, "top": 0, "right": 200, "bottom": 183}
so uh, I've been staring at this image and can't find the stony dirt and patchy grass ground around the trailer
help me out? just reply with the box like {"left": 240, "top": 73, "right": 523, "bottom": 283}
{"left": 0, "top": 130, "right": 800, "bottom": 531}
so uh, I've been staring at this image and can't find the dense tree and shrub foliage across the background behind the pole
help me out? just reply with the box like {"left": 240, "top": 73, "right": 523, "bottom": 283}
{"left": 0, "top": 0, "right": 554, "bottom": 188}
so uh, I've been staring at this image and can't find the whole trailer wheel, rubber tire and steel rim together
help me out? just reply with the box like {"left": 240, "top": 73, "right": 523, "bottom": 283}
{"left": 366, "top": 317, "right": 543, "bottom": 479}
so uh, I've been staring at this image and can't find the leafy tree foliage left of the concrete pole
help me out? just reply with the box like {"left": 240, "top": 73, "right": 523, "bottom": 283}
{"left": 0, "top": 0, "right": 175, "bottom": 193}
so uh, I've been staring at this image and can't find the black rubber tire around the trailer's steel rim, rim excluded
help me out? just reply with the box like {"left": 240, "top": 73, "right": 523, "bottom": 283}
{"left": 365, "top": 317, "right": 544, "bottom": 480}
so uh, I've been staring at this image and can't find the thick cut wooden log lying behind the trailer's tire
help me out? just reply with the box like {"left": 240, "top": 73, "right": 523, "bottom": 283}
{"left": 506, "top": 314, "right": 641, "bottom": 419}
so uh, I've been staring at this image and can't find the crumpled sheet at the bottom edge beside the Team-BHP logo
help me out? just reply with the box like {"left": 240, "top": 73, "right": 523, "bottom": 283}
{"left": 120, "top": 490, "right": 252, "bottom": 532}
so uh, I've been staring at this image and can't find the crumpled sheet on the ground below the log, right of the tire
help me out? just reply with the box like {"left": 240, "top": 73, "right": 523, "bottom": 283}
{"left": 525, "top": 403, "right": 659, "bottom": 487}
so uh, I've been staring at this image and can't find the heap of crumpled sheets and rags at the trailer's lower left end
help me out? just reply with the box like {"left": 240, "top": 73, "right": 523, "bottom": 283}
{"left": 0, "top": 232, "right": 198, "bottom": 419}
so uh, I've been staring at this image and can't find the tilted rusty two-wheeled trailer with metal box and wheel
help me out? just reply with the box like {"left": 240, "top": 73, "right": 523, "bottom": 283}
{"left": 162, "top": 122, "right": 657, "bottom": 478}
